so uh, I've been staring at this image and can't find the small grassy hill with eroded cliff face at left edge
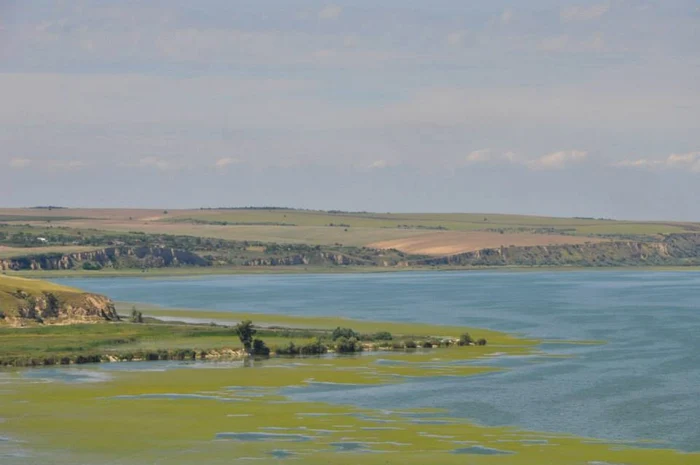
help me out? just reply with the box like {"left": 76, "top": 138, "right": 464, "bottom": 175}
{"left": 0, "top": 275, "right": 119, "bottom": 326}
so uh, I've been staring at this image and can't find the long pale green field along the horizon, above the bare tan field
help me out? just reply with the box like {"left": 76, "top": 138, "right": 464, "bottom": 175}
{"left": 5, "top": 209, "right": 700, "bottom": 245}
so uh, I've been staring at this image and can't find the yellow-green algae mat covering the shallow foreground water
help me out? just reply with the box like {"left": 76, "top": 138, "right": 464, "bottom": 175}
{"left": 1, "top": 349, "right": 700, "bottom": 465}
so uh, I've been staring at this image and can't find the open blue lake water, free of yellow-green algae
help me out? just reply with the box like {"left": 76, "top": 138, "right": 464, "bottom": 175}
{"left": 57, "top": 271, "right": 700, "bottom": 451}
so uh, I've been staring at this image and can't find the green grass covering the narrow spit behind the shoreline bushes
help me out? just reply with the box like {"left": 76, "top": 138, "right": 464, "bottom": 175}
{"left": 0, "top": 306, "right": 516, "bottom": 361}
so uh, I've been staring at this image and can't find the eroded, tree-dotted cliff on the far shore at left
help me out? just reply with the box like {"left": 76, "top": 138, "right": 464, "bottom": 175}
{"left": 0, "top": 246, "right": 210, "bottom": 271}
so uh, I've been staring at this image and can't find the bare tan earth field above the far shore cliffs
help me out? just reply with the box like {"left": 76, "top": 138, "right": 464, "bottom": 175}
{"left": 368, "top": 231, "right": 603, "bottom": 256}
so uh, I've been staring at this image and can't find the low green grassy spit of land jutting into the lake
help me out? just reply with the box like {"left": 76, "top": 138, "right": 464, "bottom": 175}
{"left": 0, "top": 306, "right": 516, "bottom": 366}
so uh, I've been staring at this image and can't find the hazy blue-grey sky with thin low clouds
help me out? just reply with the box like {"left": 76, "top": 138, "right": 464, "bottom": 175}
{"left": 0, "top": 0, "right": 700, "bottom": 221}
